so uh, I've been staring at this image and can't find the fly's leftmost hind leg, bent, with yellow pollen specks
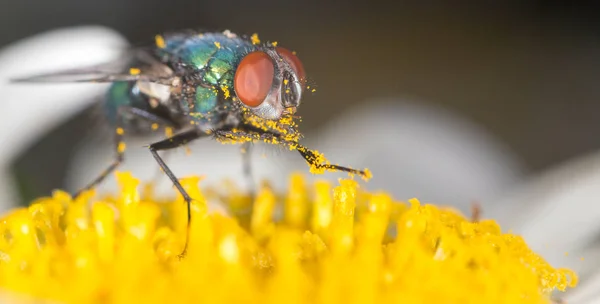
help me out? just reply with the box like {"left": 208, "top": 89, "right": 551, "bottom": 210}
{"left": 73, "top": 106, "right": 172, "bottom": 197}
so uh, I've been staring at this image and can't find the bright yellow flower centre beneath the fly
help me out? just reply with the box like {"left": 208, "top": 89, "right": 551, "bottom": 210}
{"left": 0, "top": 173, "right": 577, "bottom": 304}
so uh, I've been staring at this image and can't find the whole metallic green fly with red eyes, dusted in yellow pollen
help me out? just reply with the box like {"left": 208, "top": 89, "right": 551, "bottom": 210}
{"left": 13, "top": 27, "right": 370, "bottom": 256}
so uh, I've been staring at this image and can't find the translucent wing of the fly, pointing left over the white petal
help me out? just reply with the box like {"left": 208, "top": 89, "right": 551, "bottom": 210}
{"left": 11, "top": 48, "right": 173, "bottom": 85}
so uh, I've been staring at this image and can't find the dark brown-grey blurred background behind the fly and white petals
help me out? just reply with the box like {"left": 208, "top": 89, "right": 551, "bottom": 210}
{"left": 0, "top": 0, "right": 600, "bottom": 201}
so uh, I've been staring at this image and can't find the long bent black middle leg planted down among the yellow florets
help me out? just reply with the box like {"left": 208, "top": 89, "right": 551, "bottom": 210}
{"left": 148, "top": 129, "right": 207, "bottom": 259}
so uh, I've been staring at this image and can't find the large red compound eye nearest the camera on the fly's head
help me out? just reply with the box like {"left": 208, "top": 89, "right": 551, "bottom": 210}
{"left": 233, "top": 51, "right": 275, "bottom": 107}
